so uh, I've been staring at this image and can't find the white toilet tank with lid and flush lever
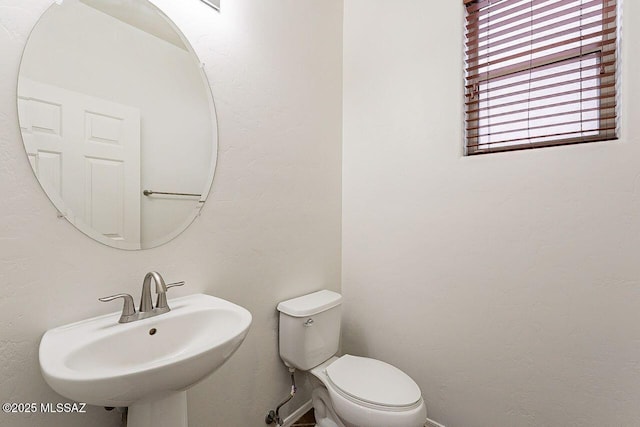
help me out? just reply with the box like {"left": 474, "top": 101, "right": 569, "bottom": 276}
{"left": 278, "top": 290, "right": 342, "bottom": 371}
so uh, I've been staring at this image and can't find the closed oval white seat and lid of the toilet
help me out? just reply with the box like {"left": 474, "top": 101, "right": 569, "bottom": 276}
{"left": 326, "top": 355, "right": 422, "bottom": 411}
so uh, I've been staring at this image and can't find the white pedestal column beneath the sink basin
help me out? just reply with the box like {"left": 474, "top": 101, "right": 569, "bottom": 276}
{"left": 127, "top": 391, "right": 188, "bottom": 427}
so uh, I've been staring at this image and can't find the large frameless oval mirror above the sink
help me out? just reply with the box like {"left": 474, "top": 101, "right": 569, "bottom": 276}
{"left": 17, "top": 0, "right": 217, "bottom": 249}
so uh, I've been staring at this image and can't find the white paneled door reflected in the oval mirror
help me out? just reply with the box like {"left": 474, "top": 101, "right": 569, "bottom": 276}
{"left": 18, "top": 78, "right": 141, "bottom": 249}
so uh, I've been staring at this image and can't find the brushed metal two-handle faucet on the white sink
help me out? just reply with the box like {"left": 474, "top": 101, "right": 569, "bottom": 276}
{"left": 98, "top": 271, "right": 184, "bottom": 323}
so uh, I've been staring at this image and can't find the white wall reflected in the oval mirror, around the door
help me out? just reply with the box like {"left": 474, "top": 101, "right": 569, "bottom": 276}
{"left": 20, "top": 1, "right": 213, "bottom": 247}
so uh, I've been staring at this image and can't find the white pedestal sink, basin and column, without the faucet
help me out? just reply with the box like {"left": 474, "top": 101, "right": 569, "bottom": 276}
{"left": 40, "top": 294, "right": 251, "bottom": 427}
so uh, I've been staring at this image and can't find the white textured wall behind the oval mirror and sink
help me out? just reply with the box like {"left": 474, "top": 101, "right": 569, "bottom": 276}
{"left": 0, "top": 0, "right": 342, "bottom": 427}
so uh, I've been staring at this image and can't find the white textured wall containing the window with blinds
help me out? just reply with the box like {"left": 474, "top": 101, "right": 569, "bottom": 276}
{"left": 342, "top": 0, "right": 640, "bottom": 427}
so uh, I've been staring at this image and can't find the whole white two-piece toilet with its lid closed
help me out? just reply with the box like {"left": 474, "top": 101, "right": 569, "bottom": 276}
{"left": 278, "top": 290, "right": 427, "bottom": 427}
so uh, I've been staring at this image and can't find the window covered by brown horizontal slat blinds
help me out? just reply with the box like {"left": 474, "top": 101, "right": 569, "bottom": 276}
{"left": 463, "top": 0, "right": 617, "bottom": 155}
